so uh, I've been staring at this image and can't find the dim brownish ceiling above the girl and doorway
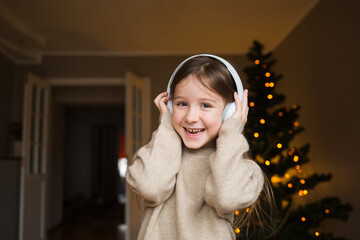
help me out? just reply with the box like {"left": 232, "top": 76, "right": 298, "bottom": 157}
{"left": 0, "top": 0, "right": 319, "bottom": 63}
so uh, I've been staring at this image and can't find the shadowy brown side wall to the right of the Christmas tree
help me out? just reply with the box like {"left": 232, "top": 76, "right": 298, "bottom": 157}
{"left": 274, "top": 0, "right": 360, "bottom": 239}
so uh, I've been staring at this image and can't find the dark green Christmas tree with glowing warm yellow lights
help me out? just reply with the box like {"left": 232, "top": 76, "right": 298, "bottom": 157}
{"left": 235, "top": 41, "right": 351, "bottom": 240}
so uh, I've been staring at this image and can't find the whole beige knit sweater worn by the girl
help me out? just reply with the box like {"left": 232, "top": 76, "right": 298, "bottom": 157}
{"left": 126, "top": 113, "right": 264, "bottom": 240}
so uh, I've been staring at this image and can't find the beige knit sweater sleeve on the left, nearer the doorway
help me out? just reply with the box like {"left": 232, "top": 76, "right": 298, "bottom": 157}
{"left": 126, "top": 113, "right": 181, "bottom": 207}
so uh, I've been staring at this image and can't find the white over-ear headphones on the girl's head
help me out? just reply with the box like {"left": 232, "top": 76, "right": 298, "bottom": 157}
{"left": 167, "top": 54, "right": 244, "bottom": 122}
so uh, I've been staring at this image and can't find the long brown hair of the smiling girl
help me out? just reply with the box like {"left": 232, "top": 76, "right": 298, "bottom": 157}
{"left": 170, "top": 56, "right": 277, "bottom": 239}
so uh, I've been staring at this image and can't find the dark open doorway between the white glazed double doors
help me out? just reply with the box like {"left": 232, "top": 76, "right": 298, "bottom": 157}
{"left": 48, "top": 86, "right": 125, "bottom": 240}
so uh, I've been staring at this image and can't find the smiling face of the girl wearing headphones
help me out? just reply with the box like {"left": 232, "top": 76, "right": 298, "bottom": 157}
{"left": 172, "top": 75, "right": 225, "bottom": 149}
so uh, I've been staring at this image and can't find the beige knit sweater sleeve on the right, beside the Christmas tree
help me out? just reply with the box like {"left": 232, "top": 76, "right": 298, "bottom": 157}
{"left": 204, "top": 118, "right": 264, "bottom": 217}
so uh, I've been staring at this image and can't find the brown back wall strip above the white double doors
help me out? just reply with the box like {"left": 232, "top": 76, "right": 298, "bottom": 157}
{"left": 13, "top": 55, "right": 248, "bottom": 133}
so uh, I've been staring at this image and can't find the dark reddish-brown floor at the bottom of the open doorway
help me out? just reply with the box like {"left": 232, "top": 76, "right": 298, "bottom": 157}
{"left": 47, "top": 204, "right": 126, "bottom": 240}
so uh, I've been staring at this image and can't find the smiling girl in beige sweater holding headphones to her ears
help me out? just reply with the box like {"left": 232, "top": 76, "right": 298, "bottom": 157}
{"left": 126, "top": 55, "right": 272, "bottom": 240}
